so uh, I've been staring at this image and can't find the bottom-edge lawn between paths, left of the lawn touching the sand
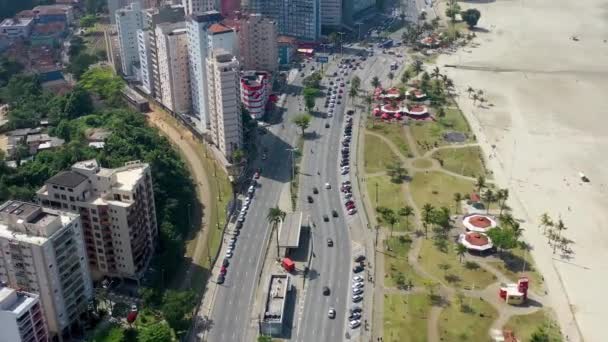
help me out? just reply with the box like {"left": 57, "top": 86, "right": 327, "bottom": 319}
{"left": 439, "top": 297, "right": 496, "bottom": 342}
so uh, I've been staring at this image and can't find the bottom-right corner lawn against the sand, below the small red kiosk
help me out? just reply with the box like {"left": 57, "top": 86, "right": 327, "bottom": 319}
{"left": 505, "top": 310, "right": 562, "bottom": 342}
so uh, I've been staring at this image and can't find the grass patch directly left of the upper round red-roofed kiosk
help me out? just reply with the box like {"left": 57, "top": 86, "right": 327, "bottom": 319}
{"left": 409, "top": 171, "right": 474, "bottom": 212}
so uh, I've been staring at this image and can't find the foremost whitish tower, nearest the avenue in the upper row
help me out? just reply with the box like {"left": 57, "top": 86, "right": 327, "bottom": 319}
{"left": 207, "top": 49, "right": 243, "bottom": 160}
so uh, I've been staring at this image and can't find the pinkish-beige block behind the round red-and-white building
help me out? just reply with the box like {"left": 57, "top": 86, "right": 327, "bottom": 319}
{"left": 239, "top": 14, "right": 279, "bottom": 72}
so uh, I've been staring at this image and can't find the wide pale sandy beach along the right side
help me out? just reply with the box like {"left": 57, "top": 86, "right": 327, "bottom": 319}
{"left": 438, "top": 0, "right": 608, "bottom": 342}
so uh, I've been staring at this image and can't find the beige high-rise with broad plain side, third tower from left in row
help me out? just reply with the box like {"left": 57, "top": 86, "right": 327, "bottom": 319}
{"left": 156, "top": 22, "right": 192, "bottom": 114}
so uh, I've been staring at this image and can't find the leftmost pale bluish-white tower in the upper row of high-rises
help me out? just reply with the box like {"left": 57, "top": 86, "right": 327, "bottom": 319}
{"left": 116, "top": 2, "right": 144, "bottom": 76}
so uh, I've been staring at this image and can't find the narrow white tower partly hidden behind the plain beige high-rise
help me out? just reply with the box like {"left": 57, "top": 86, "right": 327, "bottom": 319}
{"left": 140, "top": 5, "right": 184, "bottom": 101}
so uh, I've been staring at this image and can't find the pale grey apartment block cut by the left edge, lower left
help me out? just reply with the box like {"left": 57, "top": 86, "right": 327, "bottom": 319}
{"left": 0, "top": 201, "right": 93, "bottom": 341}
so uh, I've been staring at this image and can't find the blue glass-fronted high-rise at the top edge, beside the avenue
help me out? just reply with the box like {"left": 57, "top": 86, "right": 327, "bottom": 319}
{"left": 242, "top": 0, "right": 321, "bottom": 41}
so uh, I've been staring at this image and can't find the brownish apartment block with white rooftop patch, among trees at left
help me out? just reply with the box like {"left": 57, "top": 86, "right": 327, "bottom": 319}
{"left": 37, "top": 160, "right": 158, "bottom": 280}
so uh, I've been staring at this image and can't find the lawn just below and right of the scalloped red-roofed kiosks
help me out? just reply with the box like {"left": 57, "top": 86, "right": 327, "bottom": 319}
{"left": 410, "top": 106, "right": 471, "bottom": 152}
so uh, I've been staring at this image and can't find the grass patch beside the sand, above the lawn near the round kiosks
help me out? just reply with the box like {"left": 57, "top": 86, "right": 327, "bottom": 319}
{"left": 433, "top": 146, "right": 486, "bottom": 177}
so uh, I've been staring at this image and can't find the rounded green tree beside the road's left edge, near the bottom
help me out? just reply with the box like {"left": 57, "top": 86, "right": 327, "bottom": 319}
{"left": 161, "top": 290, "right": 196, "bottom": 331}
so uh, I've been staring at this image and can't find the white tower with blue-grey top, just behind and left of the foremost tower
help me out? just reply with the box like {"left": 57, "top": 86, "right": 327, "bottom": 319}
{"left": 186, "top": 11, "right": 236, "bottom": 132}
